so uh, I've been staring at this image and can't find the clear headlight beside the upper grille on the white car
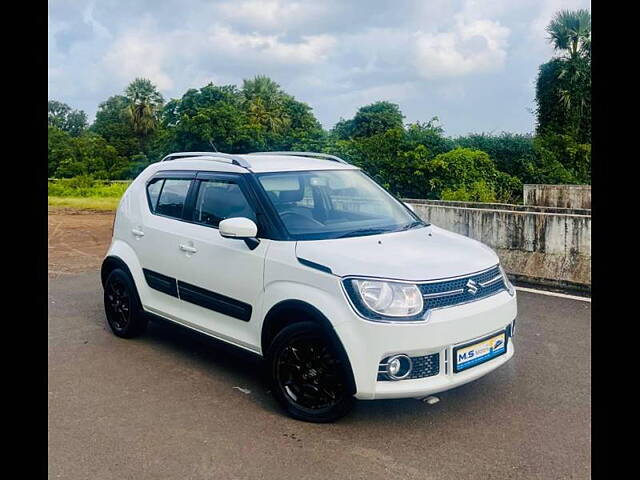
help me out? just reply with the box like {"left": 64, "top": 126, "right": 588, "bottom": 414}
{"left": 345, "top": 279, "right": 424, "bottom": 320}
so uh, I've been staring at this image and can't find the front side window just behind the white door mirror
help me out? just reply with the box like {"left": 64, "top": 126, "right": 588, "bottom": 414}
{"left": 193, "top": 179, "right": 256, "bottom": 227}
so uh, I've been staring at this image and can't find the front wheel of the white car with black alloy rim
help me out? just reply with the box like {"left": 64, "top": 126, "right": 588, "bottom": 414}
{"left": 265, "top": 321, "right": 355, "bottom": 423}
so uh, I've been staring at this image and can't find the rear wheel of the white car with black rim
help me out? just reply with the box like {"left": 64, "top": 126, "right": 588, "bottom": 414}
{"left": 104, "top": 268, "right": 148, "bottom": 338}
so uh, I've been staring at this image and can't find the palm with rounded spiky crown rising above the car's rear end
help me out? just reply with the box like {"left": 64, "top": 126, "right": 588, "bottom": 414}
{"left": 125, "top": 78, "right": 164, "bottom": 142}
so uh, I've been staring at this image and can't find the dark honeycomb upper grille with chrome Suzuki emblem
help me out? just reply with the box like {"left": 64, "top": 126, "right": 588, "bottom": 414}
{"left": 419, "top": 265, "right": 507, "bottom": 312}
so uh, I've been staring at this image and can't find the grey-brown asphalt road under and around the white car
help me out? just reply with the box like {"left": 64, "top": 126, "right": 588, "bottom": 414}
{"left": 48, "top": 272, "right": 591, "bottom": 480}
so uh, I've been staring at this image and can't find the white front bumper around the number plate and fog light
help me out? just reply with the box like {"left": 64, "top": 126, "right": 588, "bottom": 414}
{"left": 336, "top": 292, "right": 517, "bottom": 400}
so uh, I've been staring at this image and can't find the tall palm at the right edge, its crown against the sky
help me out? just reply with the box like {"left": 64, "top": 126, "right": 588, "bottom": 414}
{"left": 546, "top": 9, "right": 591, "bottom": 139}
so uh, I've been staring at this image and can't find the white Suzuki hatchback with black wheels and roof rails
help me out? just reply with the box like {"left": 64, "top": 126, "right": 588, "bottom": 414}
{"left": 101, "top": 152, "right": 517, "bottom": 422}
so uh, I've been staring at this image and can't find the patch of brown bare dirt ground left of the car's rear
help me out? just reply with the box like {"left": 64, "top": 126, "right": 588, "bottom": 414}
{"left": 48, "top": 207, "right": 114, "bottom": 278}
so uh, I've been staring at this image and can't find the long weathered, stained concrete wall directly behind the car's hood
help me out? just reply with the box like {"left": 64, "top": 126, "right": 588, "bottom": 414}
{"left": 404, "top": 199, "right": 591, "bottom": 291}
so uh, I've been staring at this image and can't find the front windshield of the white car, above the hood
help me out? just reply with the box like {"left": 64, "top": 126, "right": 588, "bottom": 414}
{"left": 258, "top": 170, "right": 425, "bottom": 240}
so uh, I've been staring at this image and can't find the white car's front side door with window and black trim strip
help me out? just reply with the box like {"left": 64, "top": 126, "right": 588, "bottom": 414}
{"left": 168, "top": 172, "right": 270, "bottom": 351}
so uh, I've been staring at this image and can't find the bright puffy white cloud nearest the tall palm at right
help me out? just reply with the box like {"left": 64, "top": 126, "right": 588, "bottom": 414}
{"left": 413, "top": 17, "right": 510, "bottom": 79}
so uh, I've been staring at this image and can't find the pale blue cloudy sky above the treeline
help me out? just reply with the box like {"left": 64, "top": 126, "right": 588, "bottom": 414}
{"left": 48, "top": 0, "right": 591, "bottom": 136}
